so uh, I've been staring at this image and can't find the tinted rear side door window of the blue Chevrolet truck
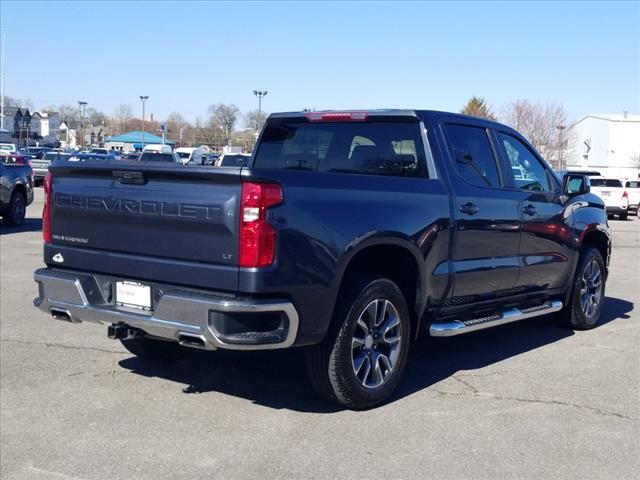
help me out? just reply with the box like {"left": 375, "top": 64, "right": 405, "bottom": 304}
{"left": 444, "top": 123, "right": 501, "bottom": 188}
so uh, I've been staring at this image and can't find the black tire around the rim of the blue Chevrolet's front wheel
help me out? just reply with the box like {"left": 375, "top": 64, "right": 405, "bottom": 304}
{"left": 559, "top": 246, "right": 606, "bottom": 330}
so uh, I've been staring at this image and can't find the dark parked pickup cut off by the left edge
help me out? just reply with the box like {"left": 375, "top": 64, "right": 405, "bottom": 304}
{"left": 0, "top": 150, "right": 33, "bottom": 226}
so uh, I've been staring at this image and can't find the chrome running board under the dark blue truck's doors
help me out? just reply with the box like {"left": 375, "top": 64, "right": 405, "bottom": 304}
{"left": 429, "top": 300, "right": 562, "bottom": 337}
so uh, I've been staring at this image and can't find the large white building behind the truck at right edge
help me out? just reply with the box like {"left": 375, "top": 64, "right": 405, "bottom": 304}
{"left": 568, "top": 113, "right": 640, "bottom": 179}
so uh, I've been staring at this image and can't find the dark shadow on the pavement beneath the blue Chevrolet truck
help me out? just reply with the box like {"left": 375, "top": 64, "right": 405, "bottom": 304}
{"left": 120, "top": 297, "right": 634, "bottom": 413}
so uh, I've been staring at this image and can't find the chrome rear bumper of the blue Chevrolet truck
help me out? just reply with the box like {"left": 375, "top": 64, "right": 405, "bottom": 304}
{"left": 33, "top": 268, "right": 298, "bottom": 350}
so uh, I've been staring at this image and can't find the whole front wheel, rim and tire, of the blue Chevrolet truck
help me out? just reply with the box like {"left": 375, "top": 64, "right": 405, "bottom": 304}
{"left": 560, "top": 246, "right": 606, "bottom": 330}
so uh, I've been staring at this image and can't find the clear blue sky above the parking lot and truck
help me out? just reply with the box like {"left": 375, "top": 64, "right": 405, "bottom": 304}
{"left": 0, "top": 0, "right": 640, "bottom": 120}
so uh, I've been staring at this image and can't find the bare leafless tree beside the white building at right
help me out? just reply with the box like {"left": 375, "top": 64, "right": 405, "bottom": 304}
{"left": 503, "top": 99, "right": 575, "bottom": 169}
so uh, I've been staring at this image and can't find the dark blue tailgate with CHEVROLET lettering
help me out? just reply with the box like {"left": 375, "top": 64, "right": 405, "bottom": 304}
{"left": 45, "top": 161, "right": 242, "bottom": 291}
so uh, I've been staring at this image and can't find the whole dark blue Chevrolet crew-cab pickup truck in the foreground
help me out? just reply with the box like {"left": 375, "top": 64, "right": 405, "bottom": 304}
{"left": 34, "top": 110, "right": 611, "bottom": 409}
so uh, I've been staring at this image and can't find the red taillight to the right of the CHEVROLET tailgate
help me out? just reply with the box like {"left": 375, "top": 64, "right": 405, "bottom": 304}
{"left": 238, "top": 183, "right": 282, "bottom": 268}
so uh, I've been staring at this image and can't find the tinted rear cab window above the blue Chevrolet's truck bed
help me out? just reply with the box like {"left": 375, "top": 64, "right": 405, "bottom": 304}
{"left": 253, "top": 116, "right": 427, "bottom": 177}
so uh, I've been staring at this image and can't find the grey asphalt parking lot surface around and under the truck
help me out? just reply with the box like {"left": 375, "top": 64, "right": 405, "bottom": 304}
{"left": 0, "top": 189, "right": 640, "bottom": 480}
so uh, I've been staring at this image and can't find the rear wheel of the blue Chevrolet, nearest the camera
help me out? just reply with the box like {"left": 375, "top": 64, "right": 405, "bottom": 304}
{"left": 306, "top": 276, "right": 411, "bottom": 410}
